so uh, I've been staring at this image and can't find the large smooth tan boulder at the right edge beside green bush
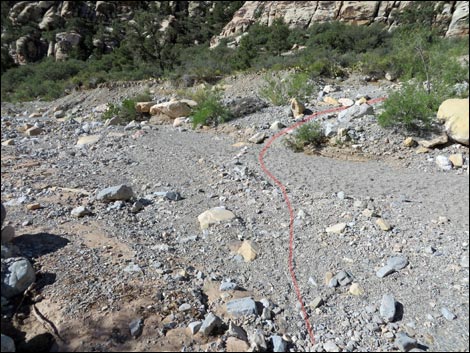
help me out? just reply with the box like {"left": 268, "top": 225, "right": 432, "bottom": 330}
{"left": 436, "top": 97, "right": 469, "bottom": 147}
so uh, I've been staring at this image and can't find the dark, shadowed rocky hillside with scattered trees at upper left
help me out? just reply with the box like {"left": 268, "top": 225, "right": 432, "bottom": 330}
{"left": 2, "top": 1, "right": 242, "bottom": 64}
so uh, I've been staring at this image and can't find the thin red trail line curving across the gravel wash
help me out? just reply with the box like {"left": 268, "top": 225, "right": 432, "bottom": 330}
{"left": 258, "top": 98, "right": 386, "bottom": 346}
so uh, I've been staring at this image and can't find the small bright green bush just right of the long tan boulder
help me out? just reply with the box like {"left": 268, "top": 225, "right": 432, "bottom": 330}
{"left": 192, "top": 90, "right": 232, "bottom": 128}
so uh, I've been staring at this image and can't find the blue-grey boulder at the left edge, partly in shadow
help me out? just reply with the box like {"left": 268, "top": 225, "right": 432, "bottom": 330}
{"left": 2, "top": 257, "right": 36, "bottom": 299}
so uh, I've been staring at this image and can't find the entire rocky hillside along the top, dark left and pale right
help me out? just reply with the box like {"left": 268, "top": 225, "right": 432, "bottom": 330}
{"left": 2, "top": 1, "right": 469, "bottom": 66}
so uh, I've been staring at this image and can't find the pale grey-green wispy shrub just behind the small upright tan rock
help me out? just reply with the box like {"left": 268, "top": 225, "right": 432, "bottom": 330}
{"left": 260, "top": 72, "right": 316, "bottom": 105}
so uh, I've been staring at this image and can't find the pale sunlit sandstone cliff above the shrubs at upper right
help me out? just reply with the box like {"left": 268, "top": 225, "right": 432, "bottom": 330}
{"left": 211, "top": 1, "right": 469, "bottom": 47}
